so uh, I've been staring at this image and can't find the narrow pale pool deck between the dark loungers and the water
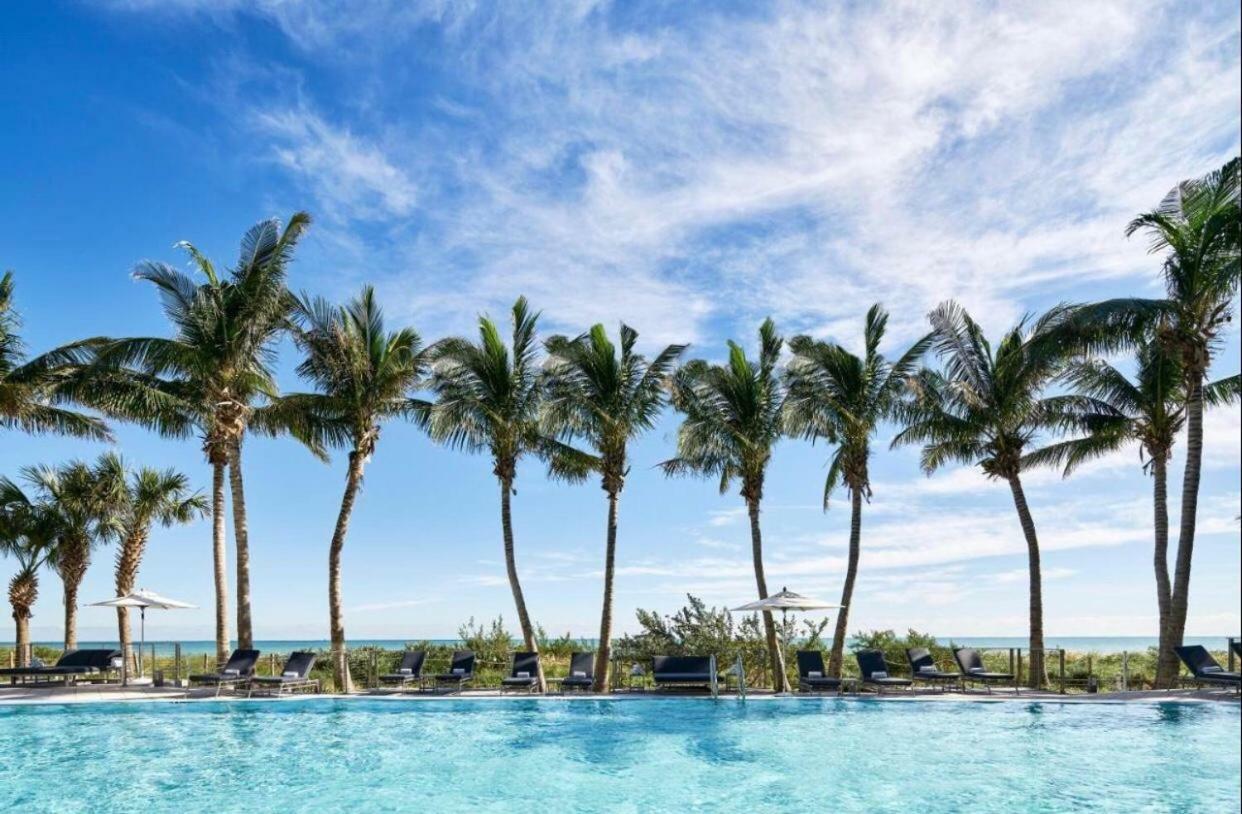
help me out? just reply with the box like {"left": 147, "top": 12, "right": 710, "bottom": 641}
{"left": 0, "top": 685, "right": 1240, "bottom": 706}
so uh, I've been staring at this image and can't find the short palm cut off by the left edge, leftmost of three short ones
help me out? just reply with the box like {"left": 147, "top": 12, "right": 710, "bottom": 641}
{"left": 0, "top": 477, "right": 60, "bottom": 667}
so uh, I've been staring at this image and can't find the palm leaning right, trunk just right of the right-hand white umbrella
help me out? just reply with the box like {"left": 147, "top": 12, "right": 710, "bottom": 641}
{"left": 785, "top": 303, "right": 932, "bottom": 677}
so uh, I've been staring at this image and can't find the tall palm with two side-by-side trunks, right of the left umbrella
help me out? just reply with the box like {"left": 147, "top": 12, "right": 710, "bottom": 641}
{"left": 91, "top": 213, "right": 311, "bottom": 661}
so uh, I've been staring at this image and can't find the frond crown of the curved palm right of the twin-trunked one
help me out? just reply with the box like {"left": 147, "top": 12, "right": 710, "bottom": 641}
{"left": 279, "top": 286, "right": 430, "bottom": 456}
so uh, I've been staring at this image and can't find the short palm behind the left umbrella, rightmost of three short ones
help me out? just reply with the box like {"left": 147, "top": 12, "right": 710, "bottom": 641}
{"left": 96, "top": 452, "right": 209, "bottom": 669}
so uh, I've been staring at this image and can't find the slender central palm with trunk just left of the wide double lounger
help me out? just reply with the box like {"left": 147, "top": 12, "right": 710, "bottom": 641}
{"left": 543, "top": 324, "right": 686, "bottom": 692}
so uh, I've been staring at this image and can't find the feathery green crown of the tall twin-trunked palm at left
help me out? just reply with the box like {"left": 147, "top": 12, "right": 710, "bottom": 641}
{"left": 79, "top": 213, "right": 311, "bottom": 455}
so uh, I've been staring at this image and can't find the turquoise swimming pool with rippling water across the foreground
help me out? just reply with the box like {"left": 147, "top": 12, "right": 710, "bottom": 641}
{"left": 0, "top": 698, "right": 1242, "bottom": 814}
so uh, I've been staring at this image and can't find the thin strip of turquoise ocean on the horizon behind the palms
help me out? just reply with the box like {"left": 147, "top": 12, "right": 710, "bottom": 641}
{"left": 7, "top": 634, "right": 1230, "bottom": 656}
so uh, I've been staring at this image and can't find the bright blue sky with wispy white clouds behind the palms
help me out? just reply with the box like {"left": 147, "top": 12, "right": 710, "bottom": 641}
{"left": 0, "top": 0, "right": 1242, "bottom": 640}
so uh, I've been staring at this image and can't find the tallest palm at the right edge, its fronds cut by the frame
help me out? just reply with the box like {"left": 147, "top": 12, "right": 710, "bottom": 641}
{"left": 1076, "top": 158, "right": 1242, "bottom": 664}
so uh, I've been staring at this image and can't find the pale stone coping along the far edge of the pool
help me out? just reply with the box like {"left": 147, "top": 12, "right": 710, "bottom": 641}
{"left": 0, "top": 686, "right": 1240, "bottom": 707}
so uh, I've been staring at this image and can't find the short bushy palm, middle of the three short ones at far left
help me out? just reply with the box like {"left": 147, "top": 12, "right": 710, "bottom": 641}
{"left": 21, "top": 461, "right": 116, "bottom": 650}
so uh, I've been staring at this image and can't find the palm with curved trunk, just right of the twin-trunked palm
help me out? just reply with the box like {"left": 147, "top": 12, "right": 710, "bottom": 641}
{"left": 282, "top": 286, "right": 430, "bottom": 692}
